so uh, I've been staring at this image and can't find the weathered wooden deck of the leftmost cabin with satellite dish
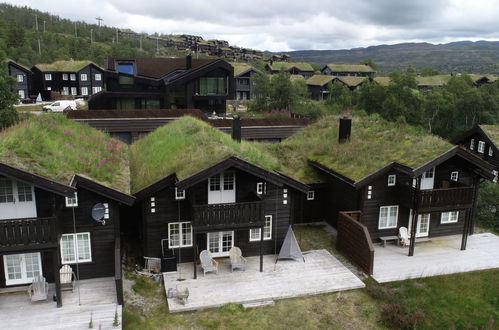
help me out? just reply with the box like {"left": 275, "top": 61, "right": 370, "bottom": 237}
{"left": 0, "top": 278, "right": 121, "bottom": 330}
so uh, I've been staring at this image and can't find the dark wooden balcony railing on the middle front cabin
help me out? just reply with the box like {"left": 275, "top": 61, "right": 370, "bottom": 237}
{"left": 192, "top": 201, "right": 265, "bottom": 230}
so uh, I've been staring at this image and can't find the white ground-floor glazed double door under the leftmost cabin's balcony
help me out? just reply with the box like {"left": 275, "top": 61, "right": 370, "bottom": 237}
{"left": 3, "top": 252, "right": 42, "bottom": 285}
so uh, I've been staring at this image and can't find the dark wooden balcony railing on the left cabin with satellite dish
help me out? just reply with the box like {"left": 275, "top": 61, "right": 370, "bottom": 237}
{"left": 0, "top": 217, "right": 57, "bottom": 251}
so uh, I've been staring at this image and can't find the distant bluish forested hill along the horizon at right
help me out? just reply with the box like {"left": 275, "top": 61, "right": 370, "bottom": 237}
{"left": 285, "top": 41, "right": 499, "bottom": 73}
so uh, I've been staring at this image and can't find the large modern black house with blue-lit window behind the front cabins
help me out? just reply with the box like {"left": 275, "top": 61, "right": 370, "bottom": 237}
{"left": 89, "top": 55, "right": 234, "bottom": 113}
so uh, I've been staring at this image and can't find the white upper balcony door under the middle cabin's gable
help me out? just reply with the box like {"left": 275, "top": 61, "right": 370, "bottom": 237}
{"left": 208, "top": 172, "right": 236, "bottom": 204}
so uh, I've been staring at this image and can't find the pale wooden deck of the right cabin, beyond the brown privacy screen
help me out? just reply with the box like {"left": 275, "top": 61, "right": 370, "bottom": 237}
{"left": 373, "top": 233, "right": 499, "bottom": 283}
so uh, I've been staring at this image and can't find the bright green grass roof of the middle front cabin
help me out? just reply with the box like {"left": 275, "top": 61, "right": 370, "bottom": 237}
{"left": 130, "top": 116, "right": 285, "bottom": 193}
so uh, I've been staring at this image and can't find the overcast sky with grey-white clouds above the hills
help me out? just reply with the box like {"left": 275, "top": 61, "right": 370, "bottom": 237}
{"left": 4, "top": 0, "right": 499, "bottom": 51}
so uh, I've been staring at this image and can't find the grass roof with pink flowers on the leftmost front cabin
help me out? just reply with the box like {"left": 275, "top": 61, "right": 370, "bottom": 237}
{"left": 0, "top": 114, "right": 130, "bottom": 193}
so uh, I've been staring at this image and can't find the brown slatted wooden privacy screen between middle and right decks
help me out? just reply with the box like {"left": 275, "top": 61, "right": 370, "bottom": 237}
{"left": 336, "top": 211, "right": 374, "bottom": 275}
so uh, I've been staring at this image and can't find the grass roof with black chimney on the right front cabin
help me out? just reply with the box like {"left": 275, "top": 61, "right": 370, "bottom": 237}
{"left": 269, "top": 116, "right": 453, "bottom": 183}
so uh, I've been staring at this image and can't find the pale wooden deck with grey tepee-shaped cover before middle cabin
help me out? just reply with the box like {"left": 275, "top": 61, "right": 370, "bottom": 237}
{"left": 163, "top": 250, "right": 365, "bottom": 312}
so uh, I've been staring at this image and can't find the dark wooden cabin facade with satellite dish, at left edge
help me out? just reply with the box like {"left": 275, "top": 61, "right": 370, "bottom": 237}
{"left": 0, "top": 163, "right": 134, "bottom": 307}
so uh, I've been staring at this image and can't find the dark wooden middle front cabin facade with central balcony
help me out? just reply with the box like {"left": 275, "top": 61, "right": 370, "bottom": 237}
{"left": 135, "top": 157, "right": 308, "bottom": 278}
